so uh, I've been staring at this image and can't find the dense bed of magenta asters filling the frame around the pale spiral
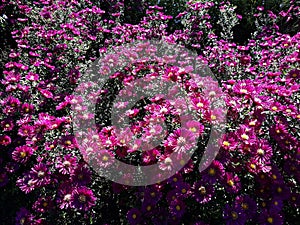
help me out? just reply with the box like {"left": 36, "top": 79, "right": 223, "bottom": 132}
{"left": 0, "top": 0, "right": 300, "bottom": 225}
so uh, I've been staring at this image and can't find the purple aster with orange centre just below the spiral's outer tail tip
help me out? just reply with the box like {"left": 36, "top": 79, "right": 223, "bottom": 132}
{"left": 202, "top": 160, "right": 224, "bottom": 184}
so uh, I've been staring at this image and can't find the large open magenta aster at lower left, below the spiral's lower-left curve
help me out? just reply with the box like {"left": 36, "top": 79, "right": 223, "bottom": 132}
{"left": 71, "top": 186, "right": 97, "bottom": 211}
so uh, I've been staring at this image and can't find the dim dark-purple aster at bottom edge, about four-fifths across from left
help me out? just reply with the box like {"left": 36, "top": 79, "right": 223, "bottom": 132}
{"left": 223, "top": 204, "right": 246, "bottom": 225}
